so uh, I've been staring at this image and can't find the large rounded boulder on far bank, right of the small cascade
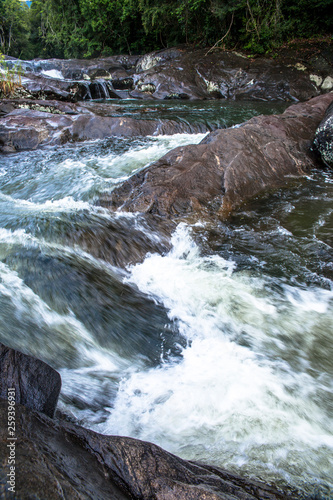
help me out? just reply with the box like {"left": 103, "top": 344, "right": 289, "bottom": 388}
{"left": 130, "top": 49, "right": 325, "bottom": 101}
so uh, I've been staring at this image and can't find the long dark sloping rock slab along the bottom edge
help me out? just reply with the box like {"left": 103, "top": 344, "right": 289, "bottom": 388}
{"left": 0, "top": 400, "right": 298, "bottom": 500}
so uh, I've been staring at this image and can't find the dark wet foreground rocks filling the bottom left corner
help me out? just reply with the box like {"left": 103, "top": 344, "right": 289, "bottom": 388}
{"left": 0, "top": 344, "right": 301, "bottom": 500}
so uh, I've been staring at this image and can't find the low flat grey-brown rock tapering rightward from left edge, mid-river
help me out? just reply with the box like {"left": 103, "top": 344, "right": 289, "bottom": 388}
{"left": 0, "top": 99, "right": 207, "bottom": 153}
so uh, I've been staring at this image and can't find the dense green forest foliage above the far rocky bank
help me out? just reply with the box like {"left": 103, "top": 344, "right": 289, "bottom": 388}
{"left": 0, "top": 0, "right": 333, "bottom": 59}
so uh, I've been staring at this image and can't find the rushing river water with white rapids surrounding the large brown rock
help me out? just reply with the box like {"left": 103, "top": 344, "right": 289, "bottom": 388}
{"left": 0, "top": 99, "right": 333, "bottom": 499}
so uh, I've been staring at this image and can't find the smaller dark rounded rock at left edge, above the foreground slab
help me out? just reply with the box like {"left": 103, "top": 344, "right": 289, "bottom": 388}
{"left": 0, "top": 343, "right": 61, "bottom": 422}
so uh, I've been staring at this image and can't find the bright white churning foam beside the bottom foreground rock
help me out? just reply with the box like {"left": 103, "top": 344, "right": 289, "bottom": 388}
{"left": 98, "top": 225, "right": 333, "bottom": 492}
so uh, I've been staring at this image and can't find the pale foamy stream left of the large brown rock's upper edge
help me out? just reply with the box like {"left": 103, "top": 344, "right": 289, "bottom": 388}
{"left": 0, "top": 134, "right": 205, "bottom": 204}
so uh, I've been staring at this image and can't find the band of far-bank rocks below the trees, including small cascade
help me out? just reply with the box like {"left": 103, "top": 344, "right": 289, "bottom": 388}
{"left": 6, "top": 48, "right": 332, "bottom": 105}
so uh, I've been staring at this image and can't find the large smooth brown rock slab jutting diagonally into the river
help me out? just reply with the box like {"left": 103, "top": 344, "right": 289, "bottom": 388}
{"left": 100, "top": 94, "right": 333, "bottom": 217}
